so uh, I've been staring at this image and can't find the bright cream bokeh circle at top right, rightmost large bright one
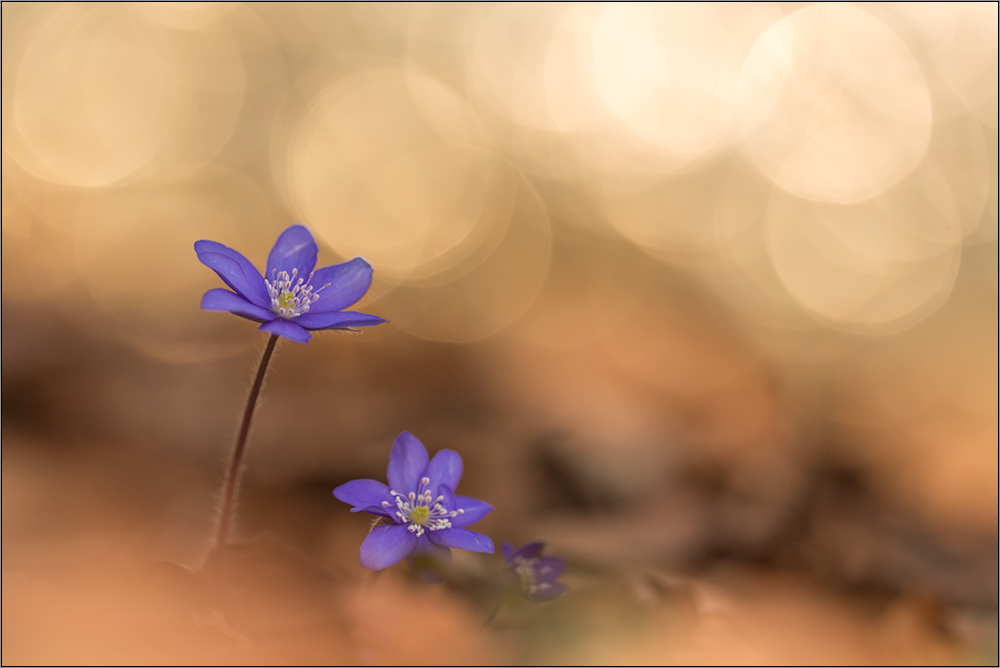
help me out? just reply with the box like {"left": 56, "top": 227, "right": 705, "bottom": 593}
{"left": 738, "top": 5, "right": 932, "bottom": 202}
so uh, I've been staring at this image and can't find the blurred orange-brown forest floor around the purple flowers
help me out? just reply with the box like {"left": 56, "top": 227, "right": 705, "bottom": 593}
{"left": 3, "top": 300, "right": 997, "bottom": 664}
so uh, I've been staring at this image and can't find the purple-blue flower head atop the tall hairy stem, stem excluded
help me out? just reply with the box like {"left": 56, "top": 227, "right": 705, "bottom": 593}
{"left": 194, "top": 225, "right": 385, "bottom": 343}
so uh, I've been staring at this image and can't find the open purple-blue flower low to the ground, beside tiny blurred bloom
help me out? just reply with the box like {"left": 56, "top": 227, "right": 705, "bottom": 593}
{"left": 333, "top": 431, "right": 493, "bottom": 579}
